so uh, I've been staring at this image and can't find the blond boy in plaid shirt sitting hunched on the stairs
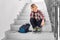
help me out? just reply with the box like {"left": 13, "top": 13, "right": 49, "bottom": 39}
{"left": 30, "top": 4, "right": 44, "bottom": 32}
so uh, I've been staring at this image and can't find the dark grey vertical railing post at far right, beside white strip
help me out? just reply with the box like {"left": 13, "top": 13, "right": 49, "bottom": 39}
{"left": 54, "top": 0, "right": 58, "bottom": 40}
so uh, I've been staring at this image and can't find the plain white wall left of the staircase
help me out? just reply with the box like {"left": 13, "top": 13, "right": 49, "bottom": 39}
{"left": 0, "top": 0, "right": 25, "bottom": 39}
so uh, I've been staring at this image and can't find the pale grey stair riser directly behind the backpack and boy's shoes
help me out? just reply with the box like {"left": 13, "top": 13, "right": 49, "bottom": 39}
{"left": 10, "top": 23, "right": 52, "bottom": 31}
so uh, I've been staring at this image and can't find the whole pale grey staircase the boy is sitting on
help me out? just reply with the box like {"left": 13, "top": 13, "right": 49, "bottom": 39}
{"left": 2, "top": 2, "right": 55, "bottom": 40}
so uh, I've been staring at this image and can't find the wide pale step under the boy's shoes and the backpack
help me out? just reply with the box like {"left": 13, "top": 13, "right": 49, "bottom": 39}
{"left": 5, "top": 31, "right": 54, "bottom": 40}
